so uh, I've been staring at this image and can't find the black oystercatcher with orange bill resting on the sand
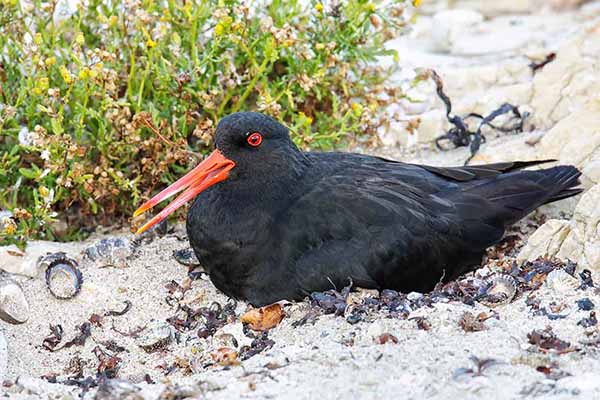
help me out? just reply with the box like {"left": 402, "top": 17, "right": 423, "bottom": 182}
{"left": 134, "top": 112, "right": 582, "bottom": 306}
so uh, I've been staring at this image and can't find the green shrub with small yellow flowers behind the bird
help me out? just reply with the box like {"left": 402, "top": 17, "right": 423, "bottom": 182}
{"left": 0, "top": 0, "right": 409, "bottom": 243}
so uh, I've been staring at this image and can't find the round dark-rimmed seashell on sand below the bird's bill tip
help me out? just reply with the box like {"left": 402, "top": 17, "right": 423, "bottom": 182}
{"left": 38, "top": 252, "right": 83, "bottom": 300}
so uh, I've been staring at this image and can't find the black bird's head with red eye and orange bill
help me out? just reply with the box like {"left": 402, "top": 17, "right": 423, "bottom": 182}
{"left": 133, "top": 112, "right": 299, "bottom": 233}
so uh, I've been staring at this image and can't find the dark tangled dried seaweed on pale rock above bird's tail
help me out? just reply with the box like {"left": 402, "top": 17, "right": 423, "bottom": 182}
{"left": 431, "top": 70, "right": 529, "bottom": 165}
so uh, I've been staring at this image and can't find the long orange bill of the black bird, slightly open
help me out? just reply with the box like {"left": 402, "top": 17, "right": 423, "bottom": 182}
{"left": 133, "top": 150, "right": 235, "bottom": 234}
